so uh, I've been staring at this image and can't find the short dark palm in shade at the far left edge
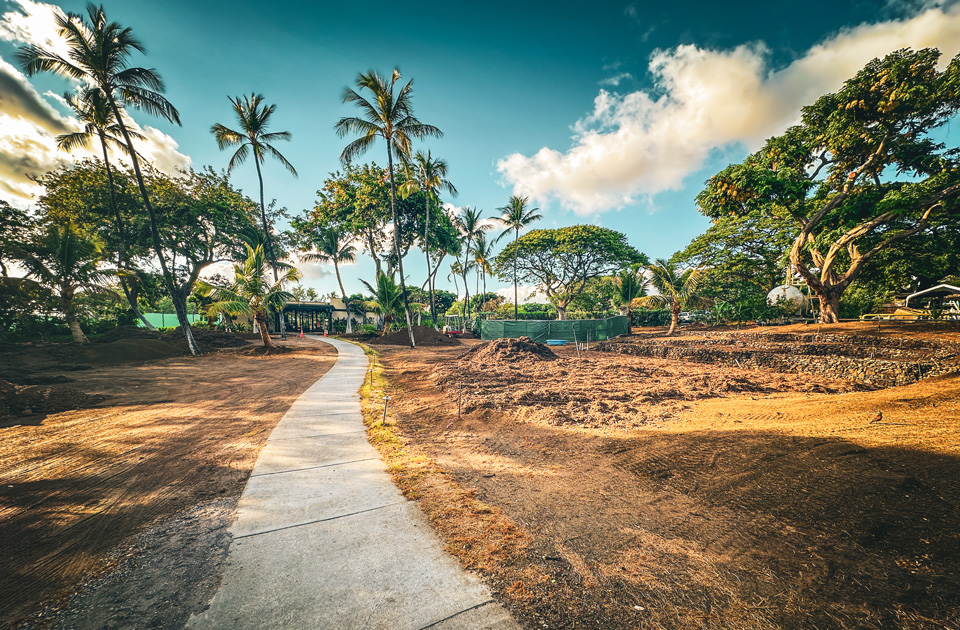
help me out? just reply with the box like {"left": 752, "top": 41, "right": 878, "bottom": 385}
{"left": 15, "top": 225, "right": 108, "bottom": 343}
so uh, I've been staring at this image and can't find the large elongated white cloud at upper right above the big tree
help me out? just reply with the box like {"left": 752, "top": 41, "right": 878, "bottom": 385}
{"left": 497, "top": 5, "right": 960, "bottom": 215}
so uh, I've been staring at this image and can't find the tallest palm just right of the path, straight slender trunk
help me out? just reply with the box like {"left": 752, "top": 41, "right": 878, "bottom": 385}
{"left": 334, "top": 68, "right": 443, "bottom": 348}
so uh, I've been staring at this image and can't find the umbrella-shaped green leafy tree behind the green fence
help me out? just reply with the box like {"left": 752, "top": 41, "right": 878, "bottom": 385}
{"left": 495, "top": 225, "right": 646, "bottom": 319}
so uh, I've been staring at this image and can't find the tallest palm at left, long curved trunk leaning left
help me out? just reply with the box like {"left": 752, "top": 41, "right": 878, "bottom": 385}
{"left": 17, "top": 3, "right": 200, "bottom": 355}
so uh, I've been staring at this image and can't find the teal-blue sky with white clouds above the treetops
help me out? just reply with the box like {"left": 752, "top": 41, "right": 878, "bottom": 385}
{"left": 0, "top": 0, "right": 960, "bottom": 302}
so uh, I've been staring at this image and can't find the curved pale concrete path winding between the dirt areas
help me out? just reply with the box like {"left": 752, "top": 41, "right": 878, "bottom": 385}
{"left": 187, "top": 338, "right": 519, "bottom": 630}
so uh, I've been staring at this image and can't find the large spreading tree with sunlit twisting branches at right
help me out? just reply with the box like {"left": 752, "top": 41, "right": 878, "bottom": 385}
{"left": 697, "top": 48, "right": 960, "bottom": 322}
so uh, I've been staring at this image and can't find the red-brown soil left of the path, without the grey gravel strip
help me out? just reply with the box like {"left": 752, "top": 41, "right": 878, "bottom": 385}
{"left": 0, "top": 338, "right": 336, "bottom": 627}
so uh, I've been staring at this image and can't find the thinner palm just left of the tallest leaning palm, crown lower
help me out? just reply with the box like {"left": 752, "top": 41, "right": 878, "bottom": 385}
{"left": 57, "top": 88, "right": 156, "bottom": 330}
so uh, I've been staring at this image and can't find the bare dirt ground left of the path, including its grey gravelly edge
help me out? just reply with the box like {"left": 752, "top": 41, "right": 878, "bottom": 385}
{"left": 0, "top": 338, "right": 336, "bottom": 628}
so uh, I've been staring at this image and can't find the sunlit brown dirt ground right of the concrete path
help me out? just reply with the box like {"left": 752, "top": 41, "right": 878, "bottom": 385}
{"left": 378, "top": 324, "right": 960, "bottom": 630}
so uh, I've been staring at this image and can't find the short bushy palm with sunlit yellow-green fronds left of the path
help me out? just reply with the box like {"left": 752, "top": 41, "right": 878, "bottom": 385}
{"left": 197, "top": 244, "right": 300, "bottom": 348}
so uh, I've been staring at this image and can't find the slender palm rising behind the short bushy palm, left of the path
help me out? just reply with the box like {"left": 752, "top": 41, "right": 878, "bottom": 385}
{"left": 210, "top": 94, "right": 297, "bottom": 282}
